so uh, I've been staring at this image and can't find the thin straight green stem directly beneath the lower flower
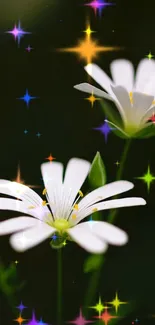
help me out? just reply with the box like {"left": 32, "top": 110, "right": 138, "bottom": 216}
{"left": 57, "top": 248, "right": 62, "bottom": 325}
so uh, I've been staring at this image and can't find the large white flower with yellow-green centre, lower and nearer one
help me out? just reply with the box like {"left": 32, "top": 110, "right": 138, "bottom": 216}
{"left": 0, "top": 158, "right": 146, "bottom": 253}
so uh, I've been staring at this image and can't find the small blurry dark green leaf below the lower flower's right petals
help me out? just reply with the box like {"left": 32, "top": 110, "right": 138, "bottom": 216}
{"left": 84, "top": 254, "right": 103, "bottom": 273}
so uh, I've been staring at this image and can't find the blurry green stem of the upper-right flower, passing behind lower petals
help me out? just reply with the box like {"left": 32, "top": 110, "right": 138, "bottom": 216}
{"left": 84, "top": 140, "right": 131, "bottom": 317}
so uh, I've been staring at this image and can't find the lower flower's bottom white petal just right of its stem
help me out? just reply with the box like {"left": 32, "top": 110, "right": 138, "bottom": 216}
{"left": 67, "top": 222, "right": 107, "bottom": 254}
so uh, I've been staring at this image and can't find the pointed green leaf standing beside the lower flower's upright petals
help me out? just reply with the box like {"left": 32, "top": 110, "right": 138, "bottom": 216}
{"left": 88, "top": 152, "right": 106, "bottom": 189}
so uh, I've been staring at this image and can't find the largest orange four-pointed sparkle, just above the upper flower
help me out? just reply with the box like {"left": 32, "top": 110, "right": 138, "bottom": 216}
{"left": 58, "top": 27, "right": 120, "bottom": 64}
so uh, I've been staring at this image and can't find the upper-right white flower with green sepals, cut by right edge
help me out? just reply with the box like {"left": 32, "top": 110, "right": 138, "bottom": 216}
{"left": 74, "top": 59, "right": 155, "bottom": 138}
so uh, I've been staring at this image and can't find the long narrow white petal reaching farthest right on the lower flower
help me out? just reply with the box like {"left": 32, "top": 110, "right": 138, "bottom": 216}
{"left": 71, "top": 197, "right": 146, "bottom": 225}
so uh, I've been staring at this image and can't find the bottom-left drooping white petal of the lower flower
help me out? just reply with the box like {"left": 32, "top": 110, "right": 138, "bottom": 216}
{"left": 10, "top": 221, "right": 56, "bottom": 252}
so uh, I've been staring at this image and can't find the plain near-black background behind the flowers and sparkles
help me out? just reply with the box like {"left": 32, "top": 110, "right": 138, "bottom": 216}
{"left": 0, "top": 0, "right": 155, "bottom": 325}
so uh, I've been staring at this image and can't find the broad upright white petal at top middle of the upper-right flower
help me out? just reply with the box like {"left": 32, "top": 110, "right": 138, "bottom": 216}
{"left": 110, "top": 59, "right": 134, "bottom": 93}
